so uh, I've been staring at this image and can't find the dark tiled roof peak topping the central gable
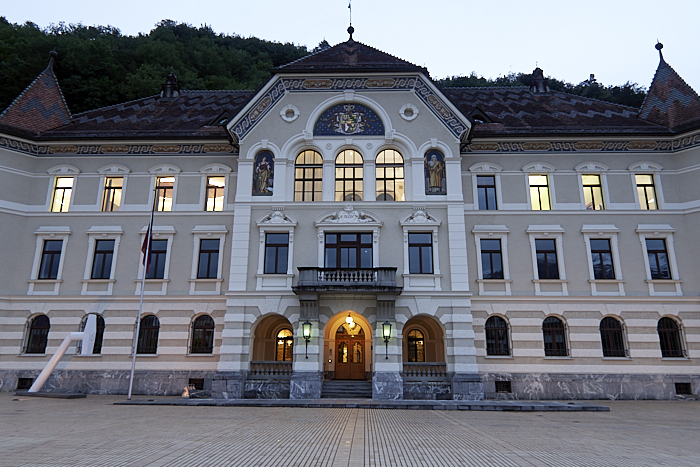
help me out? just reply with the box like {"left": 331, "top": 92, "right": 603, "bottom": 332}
{"left": 272, "top": 26, "right": 428, "bottom": 74}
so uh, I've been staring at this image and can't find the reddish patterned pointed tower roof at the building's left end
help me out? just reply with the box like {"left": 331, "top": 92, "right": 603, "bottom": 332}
{"left": 0, "top": 50, "right": 71, "bottom": 133}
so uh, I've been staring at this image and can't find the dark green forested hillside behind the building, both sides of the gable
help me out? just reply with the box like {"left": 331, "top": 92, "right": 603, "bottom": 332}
{"left": 0, "top": 17, "right": 646, "bottom": 113}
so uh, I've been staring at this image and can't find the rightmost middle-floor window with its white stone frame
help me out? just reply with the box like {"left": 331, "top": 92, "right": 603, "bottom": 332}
{"left": 637, "top": 224, "right": 683, "bottom": 295}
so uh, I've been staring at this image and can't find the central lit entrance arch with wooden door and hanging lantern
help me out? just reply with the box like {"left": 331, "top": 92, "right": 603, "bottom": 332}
{"left": 324, "top": 310, "right": 372, "bottom": 380}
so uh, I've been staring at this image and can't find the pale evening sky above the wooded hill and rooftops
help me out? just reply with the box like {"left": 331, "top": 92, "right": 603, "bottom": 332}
{"left": 5, "top": 0, "right": 700, "bottom": 92}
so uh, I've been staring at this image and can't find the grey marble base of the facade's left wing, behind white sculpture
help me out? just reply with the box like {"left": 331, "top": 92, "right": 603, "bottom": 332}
{"left": 0, "top": 370, "right": 215, "bottom": 396}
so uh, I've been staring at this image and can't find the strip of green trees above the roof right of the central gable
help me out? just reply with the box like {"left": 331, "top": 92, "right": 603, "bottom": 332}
{"left": 437, "top": 71, "right": 647, "bottom": 108}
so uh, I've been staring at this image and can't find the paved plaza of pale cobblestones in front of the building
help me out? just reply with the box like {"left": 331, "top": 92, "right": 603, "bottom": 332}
{"left": 0, "top": 393, "right": 700, "bottom": 467}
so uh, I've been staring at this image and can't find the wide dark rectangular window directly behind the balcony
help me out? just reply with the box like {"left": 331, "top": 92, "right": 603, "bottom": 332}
{"left": 325, "top": 233, "right": 372, "bottom": 269}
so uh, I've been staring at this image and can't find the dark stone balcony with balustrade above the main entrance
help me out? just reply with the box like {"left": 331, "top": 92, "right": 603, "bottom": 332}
{"left": 292, "top": 267, "right": 403, "bottom": 294}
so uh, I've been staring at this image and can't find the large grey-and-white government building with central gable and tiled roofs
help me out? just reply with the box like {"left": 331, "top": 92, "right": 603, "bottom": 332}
{"left": 0, "top": 33, "right": 700, "bottom": 400}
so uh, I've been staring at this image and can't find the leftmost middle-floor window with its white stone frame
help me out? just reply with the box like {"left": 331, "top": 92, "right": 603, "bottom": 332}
{"left": 27, "top": 226, "right": 71, "bottom": 295}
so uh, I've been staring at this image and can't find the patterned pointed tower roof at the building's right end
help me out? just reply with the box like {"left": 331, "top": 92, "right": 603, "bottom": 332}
{"left": 639, "top": 43, "right": 700, "bottom": 129}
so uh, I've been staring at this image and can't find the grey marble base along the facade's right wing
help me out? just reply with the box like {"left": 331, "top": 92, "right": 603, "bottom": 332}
{"left": 481, "top": 373, "right": 700, "bottom": 400}
